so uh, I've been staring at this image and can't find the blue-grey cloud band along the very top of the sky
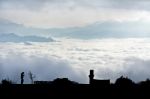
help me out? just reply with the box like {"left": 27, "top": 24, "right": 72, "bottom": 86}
{"left": 0, "top": 0, "right": 150, "bottom": 10}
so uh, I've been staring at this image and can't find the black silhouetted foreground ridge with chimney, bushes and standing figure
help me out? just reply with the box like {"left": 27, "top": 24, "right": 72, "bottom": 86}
{"left": 0, "top": 70, "right": 150, "bottom": 99}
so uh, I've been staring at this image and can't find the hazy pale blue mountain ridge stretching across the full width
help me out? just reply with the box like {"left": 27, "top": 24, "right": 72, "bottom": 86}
{"left": 0, "top": 19, "right": 150, "bottom": 39}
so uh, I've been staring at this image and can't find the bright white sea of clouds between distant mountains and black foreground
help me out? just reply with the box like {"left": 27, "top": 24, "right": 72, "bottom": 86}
{"left": 0, "top": 38, "right": 150, "bottom": 83}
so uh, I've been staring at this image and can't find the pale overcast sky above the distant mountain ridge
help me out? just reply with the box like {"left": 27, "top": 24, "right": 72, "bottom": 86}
{"left": 0, "top": 0, "right": 150, "bottom": 28}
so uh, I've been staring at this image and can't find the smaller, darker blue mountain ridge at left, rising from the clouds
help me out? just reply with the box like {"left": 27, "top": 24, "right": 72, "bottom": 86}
{"left": 0, "top": 33, "right": 54, "bottom": 42}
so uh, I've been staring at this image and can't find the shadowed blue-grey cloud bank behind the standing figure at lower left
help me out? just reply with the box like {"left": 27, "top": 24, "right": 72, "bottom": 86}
{"left": 0, "top": 52, "right": 84, "bottom": 83}
